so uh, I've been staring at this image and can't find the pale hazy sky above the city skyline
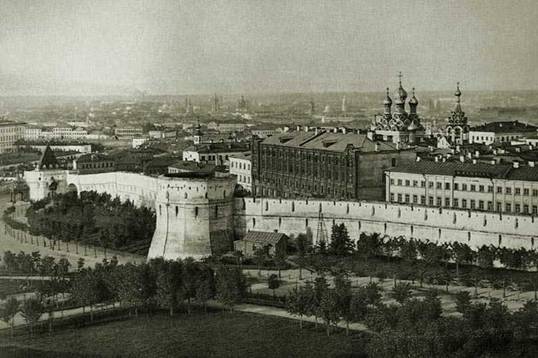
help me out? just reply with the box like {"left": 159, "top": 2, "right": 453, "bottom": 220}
{"left": 0, "top": 0, "right": 538, "bottom": 95}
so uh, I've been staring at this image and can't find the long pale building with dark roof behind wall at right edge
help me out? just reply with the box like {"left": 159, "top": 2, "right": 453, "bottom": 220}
{"left": 385, "top": 160, "right": 538, "bottom": 215}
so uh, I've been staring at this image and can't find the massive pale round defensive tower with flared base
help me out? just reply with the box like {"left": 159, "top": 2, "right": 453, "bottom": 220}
{"left": 148, "top": 173, "right": 236, "bottom": 260}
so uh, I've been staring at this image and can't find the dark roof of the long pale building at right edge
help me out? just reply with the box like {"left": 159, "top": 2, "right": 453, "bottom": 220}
{"left": 387, "top": 160, "right": 538, "bottom": 181}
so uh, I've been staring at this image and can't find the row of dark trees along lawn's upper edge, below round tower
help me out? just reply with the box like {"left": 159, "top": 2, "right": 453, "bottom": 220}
{"left": 0, "top": 256, "right": 248, "bottom": 332}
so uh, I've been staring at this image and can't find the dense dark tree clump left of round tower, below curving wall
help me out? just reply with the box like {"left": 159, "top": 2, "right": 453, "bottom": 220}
{"left": 27, "top": 191, "right": 155, "bottom": 250}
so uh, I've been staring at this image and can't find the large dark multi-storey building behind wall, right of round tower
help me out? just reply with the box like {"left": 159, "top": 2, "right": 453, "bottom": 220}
{"left": 252, "top": 129, "right": 416, "bottom": 200}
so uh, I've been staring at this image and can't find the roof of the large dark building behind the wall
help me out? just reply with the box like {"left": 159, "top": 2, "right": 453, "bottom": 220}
{"left": 262, "top": 131, "right": 397, "bottom": 152}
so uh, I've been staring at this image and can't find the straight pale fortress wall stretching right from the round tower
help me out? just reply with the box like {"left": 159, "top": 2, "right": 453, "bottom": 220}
{"left": 235, "top": 198, "right": 538, "bottom": 249}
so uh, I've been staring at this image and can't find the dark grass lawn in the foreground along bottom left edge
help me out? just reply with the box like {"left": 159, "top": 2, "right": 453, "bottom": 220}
{"left": 0, "top": 311, "right": 360, "bottom": 357}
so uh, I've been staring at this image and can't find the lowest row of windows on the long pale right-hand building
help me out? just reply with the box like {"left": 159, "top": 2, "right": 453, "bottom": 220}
{"left": 390, "top": 194, "right": 538, "bottom": 215}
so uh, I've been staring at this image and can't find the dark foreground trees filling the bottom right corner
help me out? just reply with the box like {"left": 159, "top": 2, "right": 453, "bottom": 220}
{"left": 287, "top": 274, "right": 538, "bottom": 358}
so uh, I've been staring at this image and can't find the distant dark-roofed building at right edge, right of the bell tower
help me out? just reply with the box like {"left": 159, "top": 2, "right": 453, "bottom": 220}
{"left": 469, "top": 121, "right": 538, "bottom": 144}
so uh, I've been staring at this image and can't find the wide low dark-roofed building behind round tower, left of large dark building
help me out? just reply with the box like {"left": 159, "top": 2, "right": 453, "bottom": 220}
{"left": 183, "top": 142, "right": 250, "bottom": 166}
